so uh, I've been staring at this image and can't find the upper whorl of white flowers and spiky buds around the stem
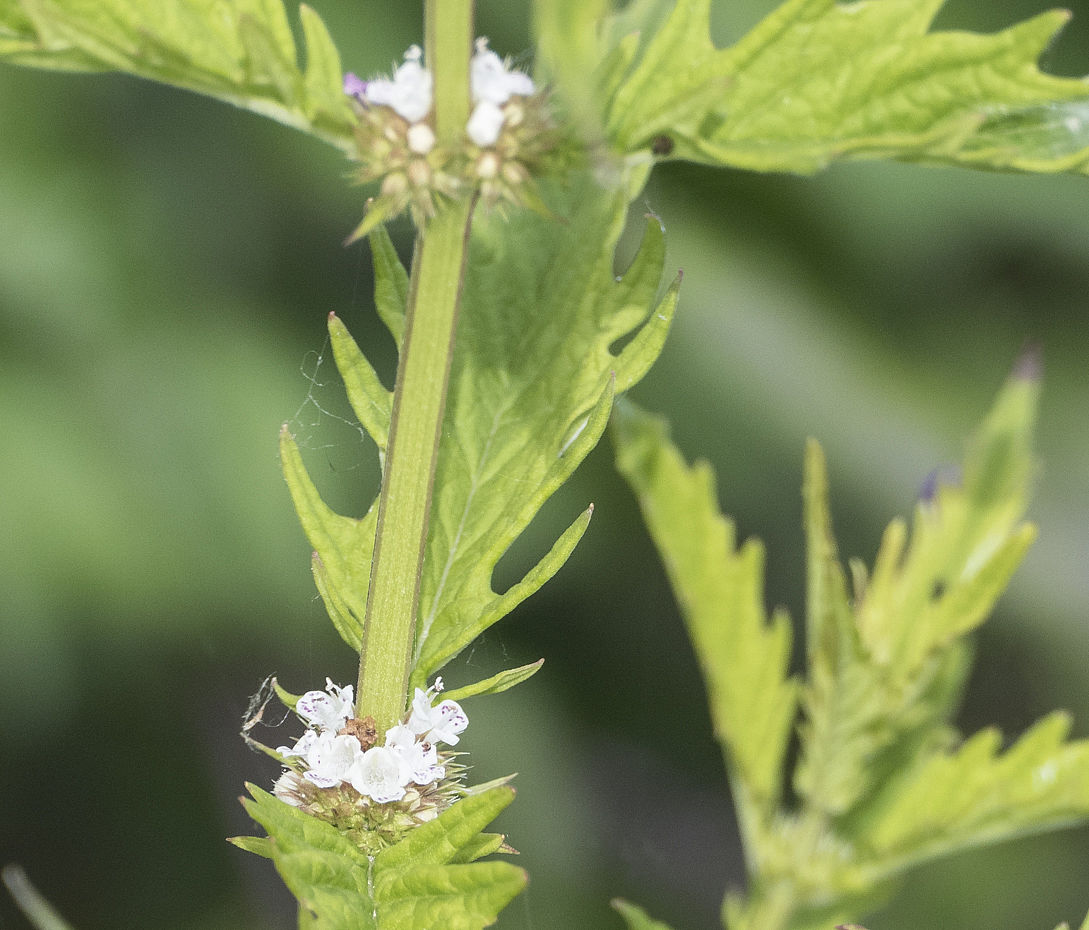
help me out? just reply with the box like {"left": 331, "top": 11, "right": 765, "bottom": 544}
{"left": 344, "top": 38, "right": 554, "bottom": 240}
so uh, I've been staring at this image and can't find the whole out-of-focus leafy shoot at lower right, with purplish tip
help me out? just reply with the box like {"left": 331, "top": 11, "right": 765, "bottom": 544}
{"left": 615, "top": 368, "right": 1089, "bottom": 930}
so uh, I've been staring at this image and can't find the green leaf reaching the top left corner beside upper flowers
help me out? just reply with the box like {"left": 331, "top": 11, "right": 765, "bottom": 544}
{"left": 0, "top": 0, "right": 355, "bottom": 154}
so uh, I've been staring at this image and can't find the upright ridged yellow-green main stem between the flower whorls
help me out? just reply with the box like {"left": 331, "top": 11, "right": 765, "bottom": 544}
{"left": 356, "top": 0, "right": 474, "bottom": 737}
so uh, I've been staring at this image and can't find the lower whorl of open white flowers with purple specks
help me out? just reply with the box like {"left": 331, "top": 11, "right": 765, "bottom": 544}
{"left": 273, "top": 678, "right": 468, "bottom": 848}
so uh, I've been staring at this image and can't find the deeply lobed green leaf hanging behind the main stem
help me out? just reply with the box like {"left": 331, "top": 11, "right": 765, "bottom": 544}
{"left": 281, "top": 178, "right": 678, "bottom": 693}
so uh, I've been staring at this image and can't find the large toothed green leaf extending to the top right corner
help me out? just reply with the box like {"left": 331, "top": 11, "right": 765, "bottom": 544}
{"left": 592, "top": 0, "right": 1089, "bottom": 173}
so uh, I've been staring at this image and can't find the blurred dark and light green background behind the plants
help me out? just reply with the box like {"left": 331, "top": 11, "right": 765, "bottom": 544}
{"left": 0, "top": 0, "right": 1089, "bottom": 930}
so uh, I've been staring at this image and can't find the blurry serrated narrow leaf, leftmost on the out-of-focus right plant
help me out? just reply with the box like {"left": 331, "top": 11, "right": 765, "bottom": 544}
{"left": 613, "top": 402, "right": 797, "bottom": 842}
